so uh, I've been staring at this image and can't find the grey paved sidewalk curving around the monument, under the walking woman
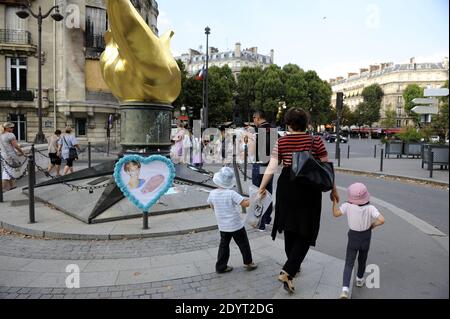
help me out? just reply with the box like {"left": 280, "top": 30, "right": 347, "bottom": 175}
{"left": 0, "top": 188, "right": 344, "bottom": 299}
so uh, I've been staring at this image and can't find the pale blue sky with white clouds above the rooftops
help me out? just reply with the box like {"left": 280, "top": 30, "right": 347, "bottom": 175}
{"left": 157, "top": 0, "right": 449, "bottom": 80}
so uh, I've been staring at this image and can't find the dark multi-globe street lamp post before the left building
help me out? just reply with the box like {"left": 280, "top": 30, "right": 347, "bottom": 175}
{"left": 16, "top": 5, "right": 64, "bottom": 144}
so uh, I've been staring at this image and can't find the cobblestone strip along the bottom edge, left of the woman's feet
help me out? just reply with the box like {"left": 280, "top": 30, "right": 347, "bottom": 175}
{"left": 0, "top": 262, "right": 280, "bottom": 299}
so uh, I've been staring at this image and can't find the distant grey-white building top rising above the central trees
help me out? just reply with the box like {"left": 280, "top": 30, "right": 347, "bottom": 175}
{"left": 176, "top": 43, "right": 274, "bottom": 76}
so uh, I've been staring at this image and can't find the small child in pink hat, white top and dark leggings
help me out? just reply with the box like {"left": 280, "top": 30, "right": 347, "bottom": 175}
{"left": 333, "top": 183, "right": 384, "bottom": 299}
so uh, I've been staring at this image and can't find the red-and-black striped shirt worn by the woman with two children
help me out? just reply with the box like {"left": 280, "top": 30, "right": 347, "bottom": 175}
{"left": 272, "top": 133, "right": 328, "bottom": 167}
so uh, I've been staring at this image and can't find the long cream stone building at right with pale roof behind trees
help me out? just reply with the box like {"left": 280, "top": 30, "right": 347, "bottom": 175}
{"left": 329, "top": 57, "right": 449, "bottom": 127}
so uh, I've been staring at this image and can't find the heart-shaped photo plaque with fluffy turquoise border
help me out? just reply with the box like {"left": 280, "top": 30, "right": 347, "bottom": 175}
{"left": 114, "top": 155, "right": 175, "bottom": 212}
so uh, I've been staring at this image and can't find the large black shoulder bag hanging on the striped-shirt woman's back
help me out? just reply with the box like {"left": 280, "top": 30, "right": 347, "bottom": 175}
{"left": 291, "top": 137, "right": 334, "bottom": 192}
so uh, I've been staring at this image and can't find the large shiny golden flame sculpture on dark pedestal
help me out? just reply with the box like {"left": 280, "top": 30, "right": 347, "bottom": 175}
{"left": 100, "top": 0, "right": 181, "bottom": 104}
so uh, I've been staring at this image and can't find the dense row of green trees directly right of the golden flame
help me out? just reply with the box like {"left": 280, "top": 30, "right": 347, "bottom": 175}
{"left": 178, "top": 64, "right": 333, "bottom": 125}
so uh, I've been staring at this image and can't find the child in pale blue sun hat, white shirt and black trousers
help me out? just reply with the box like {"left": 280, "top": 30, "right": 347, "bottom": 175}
{"left": 208, "top": 167, "right": 257, "bottom": 273}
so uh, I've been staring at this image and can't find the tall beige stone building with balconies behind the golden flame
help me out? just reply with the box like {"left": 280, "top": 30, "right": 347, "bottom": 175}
{"left": 0, "top": 0, "right": 158, "bottom": 144}
